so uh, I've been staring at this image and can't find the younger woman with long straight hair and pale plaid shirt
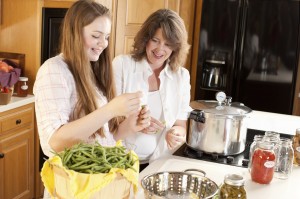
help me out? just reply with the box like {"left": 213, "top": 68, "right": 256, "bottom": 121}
{"left": 33, "top": 0, "right": 150, "bottom": 157}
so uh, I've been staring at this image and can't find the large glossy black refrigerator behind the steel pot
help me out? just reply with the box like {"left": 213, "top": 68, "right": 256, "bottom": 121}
{"left": 195, "top": 0, "right": 300, "bottom": 114}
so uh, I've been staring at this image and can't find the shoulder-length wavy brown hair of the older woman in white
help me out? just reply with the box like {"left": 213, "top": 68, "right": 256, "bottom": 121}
{"left": 131, "top": 9, "right": 190, "bottom": 71}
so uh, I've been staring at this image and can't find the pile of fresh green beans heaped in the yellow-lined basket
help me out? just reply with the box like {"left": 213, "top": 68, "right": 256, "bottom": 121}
{"left": 55, "top": 143, "right": 138, "bottom": 174}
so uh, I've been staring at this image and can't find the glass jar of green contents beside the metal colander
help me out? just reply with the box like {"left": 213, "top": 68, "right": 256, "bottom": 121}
{"left": 219, "top": 174, "right": 247, "bottom": 199}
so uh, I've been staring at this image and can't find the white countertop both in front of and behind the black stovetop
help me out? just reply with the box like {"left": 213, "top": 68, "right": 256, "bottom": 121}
{"left": 136, "top": 111, "right": 300, "bottom": 199}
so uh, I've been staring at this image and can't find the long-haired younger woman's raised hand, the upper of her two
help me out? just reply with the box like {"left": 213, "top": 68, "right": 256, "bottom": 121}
{"left": 109, "top": 91, "right": 143, "bottom": 117}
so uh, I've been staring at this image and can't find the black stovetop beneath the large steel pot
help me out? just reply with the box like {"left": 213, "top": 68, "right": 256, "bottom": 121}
{"left": 173, "top": 129, "right": 292, "bottom": 168}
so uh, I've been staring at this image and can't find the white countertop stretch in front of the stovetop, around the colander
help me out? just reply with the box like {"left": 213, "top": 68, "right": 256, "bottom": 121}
{"left": 136, "top": 156, "right": 300, "bottom": 199}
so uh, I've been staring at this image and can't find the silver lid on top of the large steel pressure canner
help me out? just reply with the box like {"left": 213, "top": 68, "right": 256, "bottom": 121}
{"left": 190, "top": 100, "right": 252, "bottom": 116}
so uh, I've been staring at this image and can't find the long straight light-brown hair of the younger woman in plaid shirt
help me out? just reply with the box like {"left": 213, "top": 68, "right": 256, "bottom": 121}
{"left": 61, "top": 0, "right": 121, "bottom": 137}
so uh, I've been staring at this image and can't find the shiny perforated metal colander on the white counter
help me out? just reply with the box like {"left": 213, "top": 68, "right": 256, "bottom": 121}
{"left": 141, "top": 169, "right": 219, "bottom": 199}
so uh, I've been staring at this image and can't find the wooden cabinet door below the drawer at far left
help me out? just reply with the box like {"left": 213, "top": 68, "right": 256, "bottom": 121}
{"left": 0, "top": 129, "right": 34, "bottom": 199}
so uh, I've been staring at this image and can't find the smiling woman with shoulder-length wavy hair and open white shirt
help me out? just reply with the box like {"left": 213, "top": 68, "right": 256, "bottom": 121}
{"left": 113, "top": 9, "right": 191, "bottom": 167}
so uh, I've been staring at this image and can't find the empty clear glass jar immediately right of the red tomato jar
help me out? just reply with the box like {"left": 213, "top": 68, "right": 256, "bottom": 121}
{"left": 275, "top": 138, "right": 294, "bottom": 179}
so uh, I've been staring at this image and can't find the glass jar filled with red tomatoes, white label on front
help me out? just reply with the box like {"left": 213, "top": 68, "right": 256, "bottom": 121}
{"left": 251, "top": 142, "right": 275, "bottom": 184}
